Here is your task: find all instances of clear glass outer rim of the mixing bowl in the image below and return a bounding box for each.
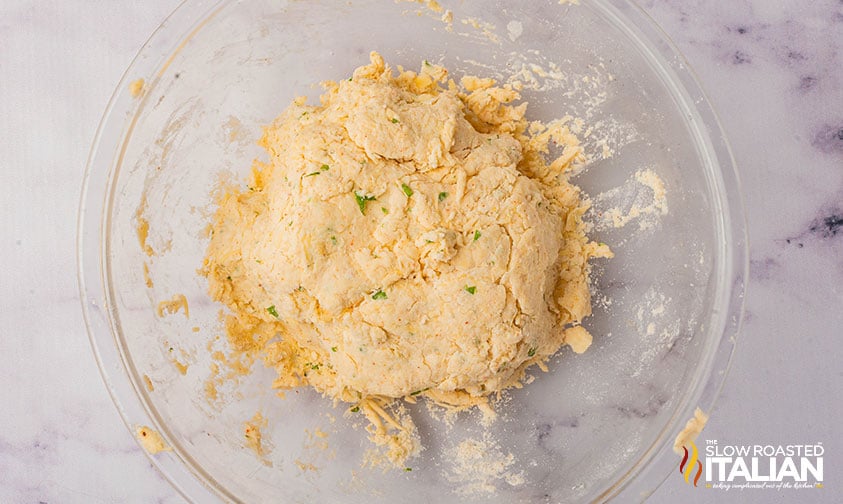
[77,0,749,502]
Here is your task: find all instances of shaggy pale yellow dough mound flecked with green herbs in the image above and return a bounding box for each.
[203,53,611,463]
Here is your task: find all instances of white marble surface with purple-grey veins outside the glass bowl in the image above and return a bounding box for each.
[0,0,843,503]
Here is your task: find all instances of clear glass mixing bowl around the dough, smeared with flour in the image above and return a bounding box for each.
[79,0,747,502]
